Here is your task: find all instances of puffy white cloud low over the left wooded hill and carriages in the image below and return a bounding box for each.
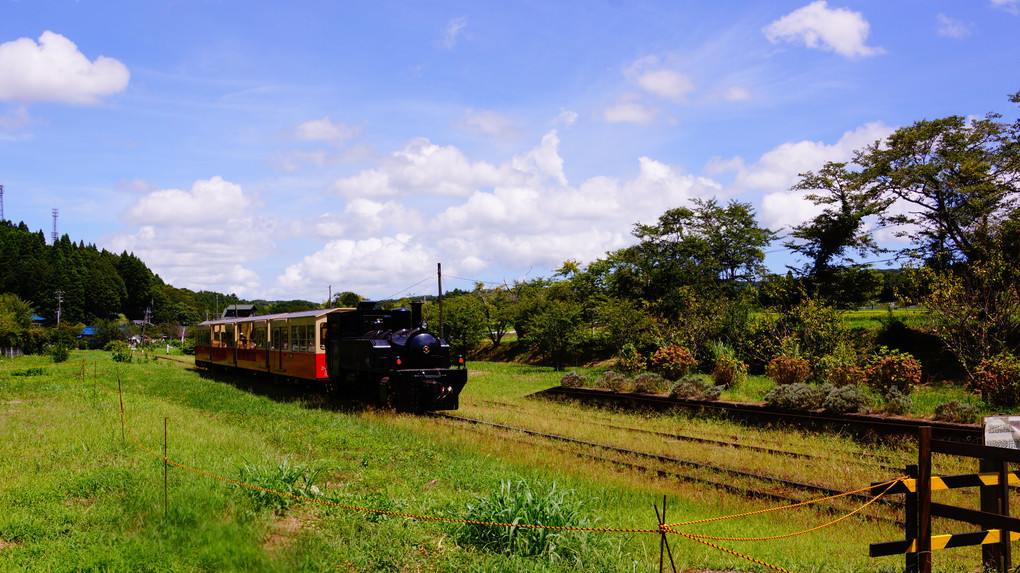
[103,176,273,296]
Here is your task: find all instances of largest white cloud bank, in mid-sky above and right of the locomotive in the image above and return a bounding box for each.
[275,131,723,296]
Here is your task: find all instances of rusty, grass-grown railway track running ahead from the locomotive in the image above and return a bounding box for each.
[429,412,902,521]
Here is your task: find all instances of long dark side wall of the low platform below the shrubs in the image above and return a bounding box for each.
[531,386,983,444]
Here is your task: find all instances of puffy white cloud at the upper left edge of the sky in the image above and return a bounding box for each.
[0,31,131,105]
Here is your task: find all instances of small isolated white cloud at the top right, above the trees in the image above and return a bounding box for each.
[763,0,884,57]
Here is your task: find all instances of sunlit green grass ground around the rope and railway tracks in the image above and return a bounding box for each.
[0,352,991,572]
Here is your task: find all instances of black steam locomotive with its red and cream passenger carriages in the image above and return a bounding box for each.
[195,301,467,413]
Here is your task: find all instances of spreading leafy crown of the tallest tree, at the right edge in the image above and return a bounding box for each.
[855,102,1020,269]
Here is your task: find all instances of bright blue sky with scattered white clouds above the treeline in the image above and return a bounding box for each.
[0,0,1020,301]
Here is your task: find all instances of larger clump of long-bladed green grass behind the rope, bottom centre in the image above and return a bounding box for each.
[458,480,595,562]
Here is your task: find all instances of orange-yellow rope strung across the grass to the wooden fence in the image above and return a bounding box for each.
[71,366,907,573]
